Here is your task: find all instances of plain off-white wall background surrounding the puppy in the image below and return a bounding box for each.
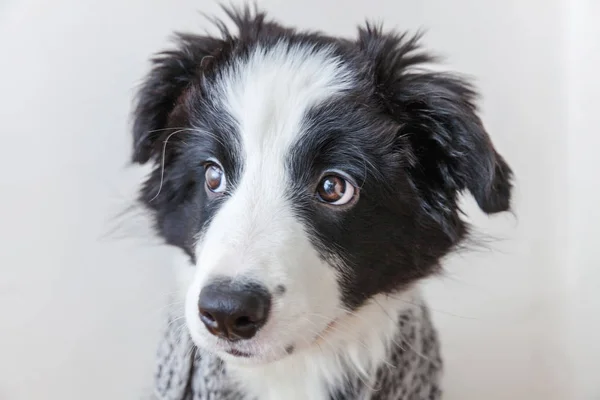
[0,0,600,400]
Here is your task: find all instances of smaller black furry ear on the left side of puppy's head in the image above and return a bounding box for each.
[132,34,225,164]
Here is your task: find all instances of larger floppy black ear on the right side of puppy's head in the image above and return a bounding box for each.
[358,25,512,214]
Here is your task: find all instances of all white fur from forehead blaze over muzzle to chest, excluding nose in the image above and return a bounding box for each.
[173,45,418,400]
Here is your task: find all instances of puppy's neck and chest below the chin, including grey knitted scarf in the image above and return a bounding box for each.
[149,291,441,400]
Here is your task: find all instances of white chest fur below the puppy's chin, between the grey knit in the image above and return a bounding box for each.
[228,290,420,400]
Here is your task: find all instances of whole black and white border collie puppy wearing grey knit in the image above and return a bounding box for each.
[133,9,512,400]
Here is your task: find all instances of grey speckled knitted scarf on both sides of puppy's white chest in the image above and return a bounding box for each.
[150,306,442,400]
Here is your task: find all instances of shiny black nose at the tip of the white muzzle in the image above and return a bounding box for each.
[198,279,271,341]
